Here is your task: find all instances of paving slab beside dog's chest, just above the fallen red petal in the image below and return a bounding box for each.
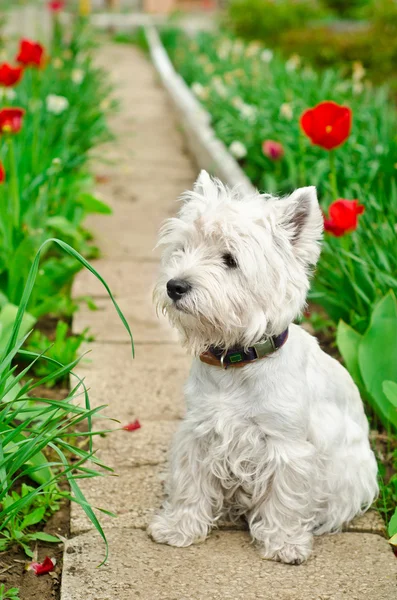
[76,343,191,423]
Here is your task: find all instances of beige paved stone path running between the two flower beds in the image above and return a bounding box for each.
[61,45,397,600]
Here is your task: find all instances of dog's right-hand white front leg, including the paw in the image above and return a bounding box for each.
[248,439,315,564]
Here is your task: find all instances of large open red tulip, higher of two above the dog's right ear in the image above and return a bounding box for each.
[300,102,352,150]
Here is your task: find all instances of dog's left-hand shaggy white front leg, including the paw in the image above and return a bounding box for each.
[148,422,223,546]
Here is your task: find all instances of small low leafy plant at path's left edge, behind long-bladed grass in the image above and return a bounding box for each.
[25,321,90,387]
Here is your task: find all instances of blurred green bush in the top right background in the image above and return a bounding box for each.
[226,0,397,89]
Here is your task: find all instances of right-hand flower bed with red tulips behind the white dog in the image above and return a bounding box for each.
[158,29,397,535]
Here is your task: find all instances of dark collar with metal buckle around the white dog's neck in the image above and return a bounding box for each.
[200,328,288,369]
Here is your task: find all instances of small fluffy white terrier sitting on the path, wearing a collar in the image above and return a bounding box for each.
[149,171,378,563]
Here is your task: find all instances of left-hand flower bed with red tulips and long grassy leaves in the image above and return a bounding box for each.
[0,7,131,598]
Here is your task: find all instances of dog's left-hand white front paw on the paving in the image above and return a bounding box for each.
[147,513,207,548]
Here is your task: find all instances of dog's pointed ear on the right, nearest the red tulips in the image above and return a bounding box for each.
[284,186,324,264]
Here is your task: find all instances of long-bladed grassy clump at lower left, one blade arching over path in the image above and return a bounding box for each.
[0,239,132,554]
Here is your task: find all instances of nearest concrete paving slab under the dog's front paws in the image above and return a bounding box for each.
[62,528,397,600]
